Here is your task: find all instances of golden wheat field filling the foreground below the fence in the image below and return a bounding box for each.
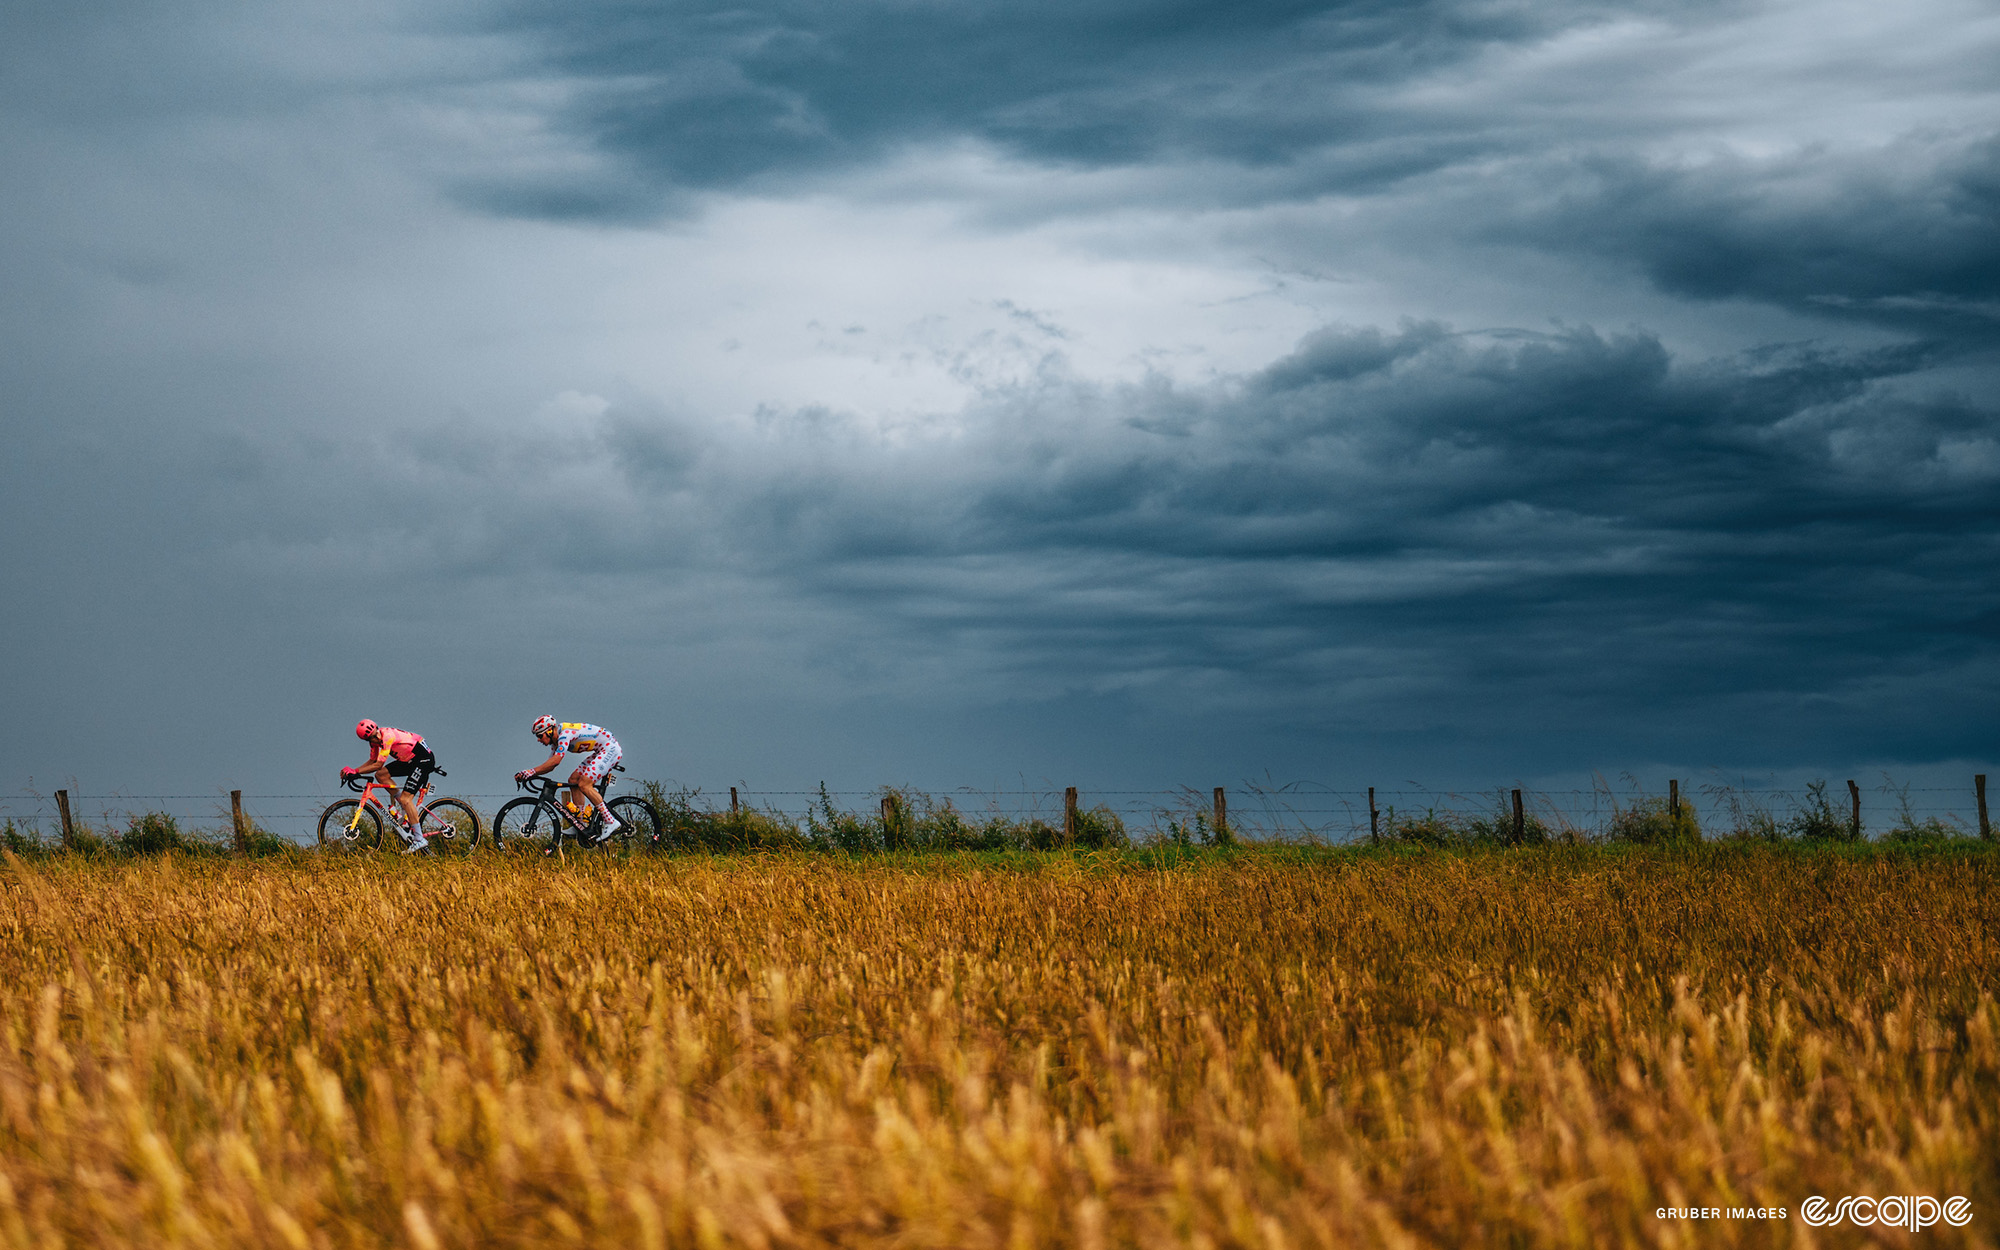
[0,848,2000,1250]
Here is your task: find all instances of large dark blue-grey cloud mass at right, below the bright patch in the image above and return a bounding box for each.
[656,326,2000,750]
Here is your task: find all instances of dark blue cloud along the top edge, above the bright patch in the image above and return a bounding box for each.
[464,0,1656,218]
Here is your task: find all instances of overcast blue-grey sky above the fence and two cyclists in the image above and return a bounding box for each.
[0,0,2000,794]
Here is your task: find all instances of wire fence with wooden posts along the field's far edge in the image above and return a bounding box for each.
[0,774,1988,844]
